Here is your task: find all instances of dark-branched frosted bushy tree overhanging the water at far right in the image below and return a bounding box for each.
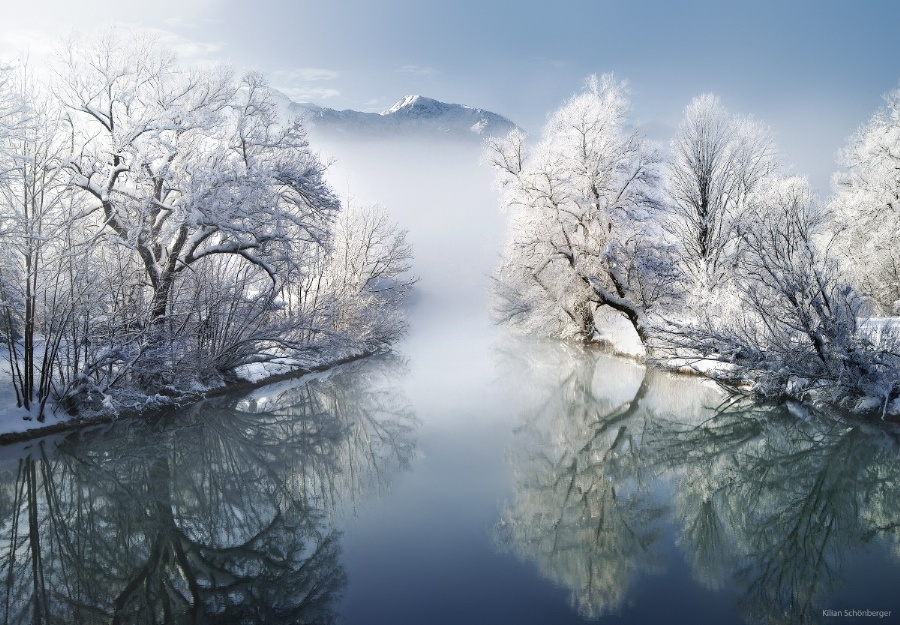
[652,178,900,409]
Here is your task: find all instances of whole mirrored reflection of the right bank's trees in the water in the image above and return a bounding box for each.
[497,346,900,623]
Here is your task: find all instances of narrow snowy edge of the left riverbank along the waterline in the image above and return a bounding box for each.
[0,351,381,445]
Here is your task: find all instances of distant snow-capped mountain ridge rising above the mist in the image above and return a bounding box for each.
[287,95,516,139]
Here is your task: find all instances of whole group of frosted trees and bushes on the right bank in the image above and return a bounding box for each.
[486,76,900,418]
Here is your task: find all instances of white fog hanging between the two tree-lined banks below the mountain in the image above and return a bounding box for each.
[321,138,505,312]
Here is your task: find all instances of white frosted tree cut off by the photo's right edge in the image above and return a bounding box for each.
[831,89,900,314]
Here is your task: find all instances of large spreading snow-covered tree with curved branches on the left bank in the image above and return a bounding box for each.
[50,34,348,394]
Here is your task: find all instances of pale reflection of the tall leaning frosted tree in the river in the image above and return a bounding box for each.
[497,342,662,618]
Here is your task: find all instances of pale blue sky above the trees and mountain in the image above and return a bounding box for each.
[0,0,900,195]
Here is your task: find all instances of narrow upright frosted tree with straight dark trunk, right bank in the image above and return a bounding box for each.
[667,93,775,290]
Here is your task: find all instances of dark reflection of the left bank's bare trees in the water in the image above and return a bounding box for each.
[0,362,416,624]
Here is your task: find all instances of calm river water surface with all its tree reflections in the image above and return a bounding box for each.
[0,342,900,624]
